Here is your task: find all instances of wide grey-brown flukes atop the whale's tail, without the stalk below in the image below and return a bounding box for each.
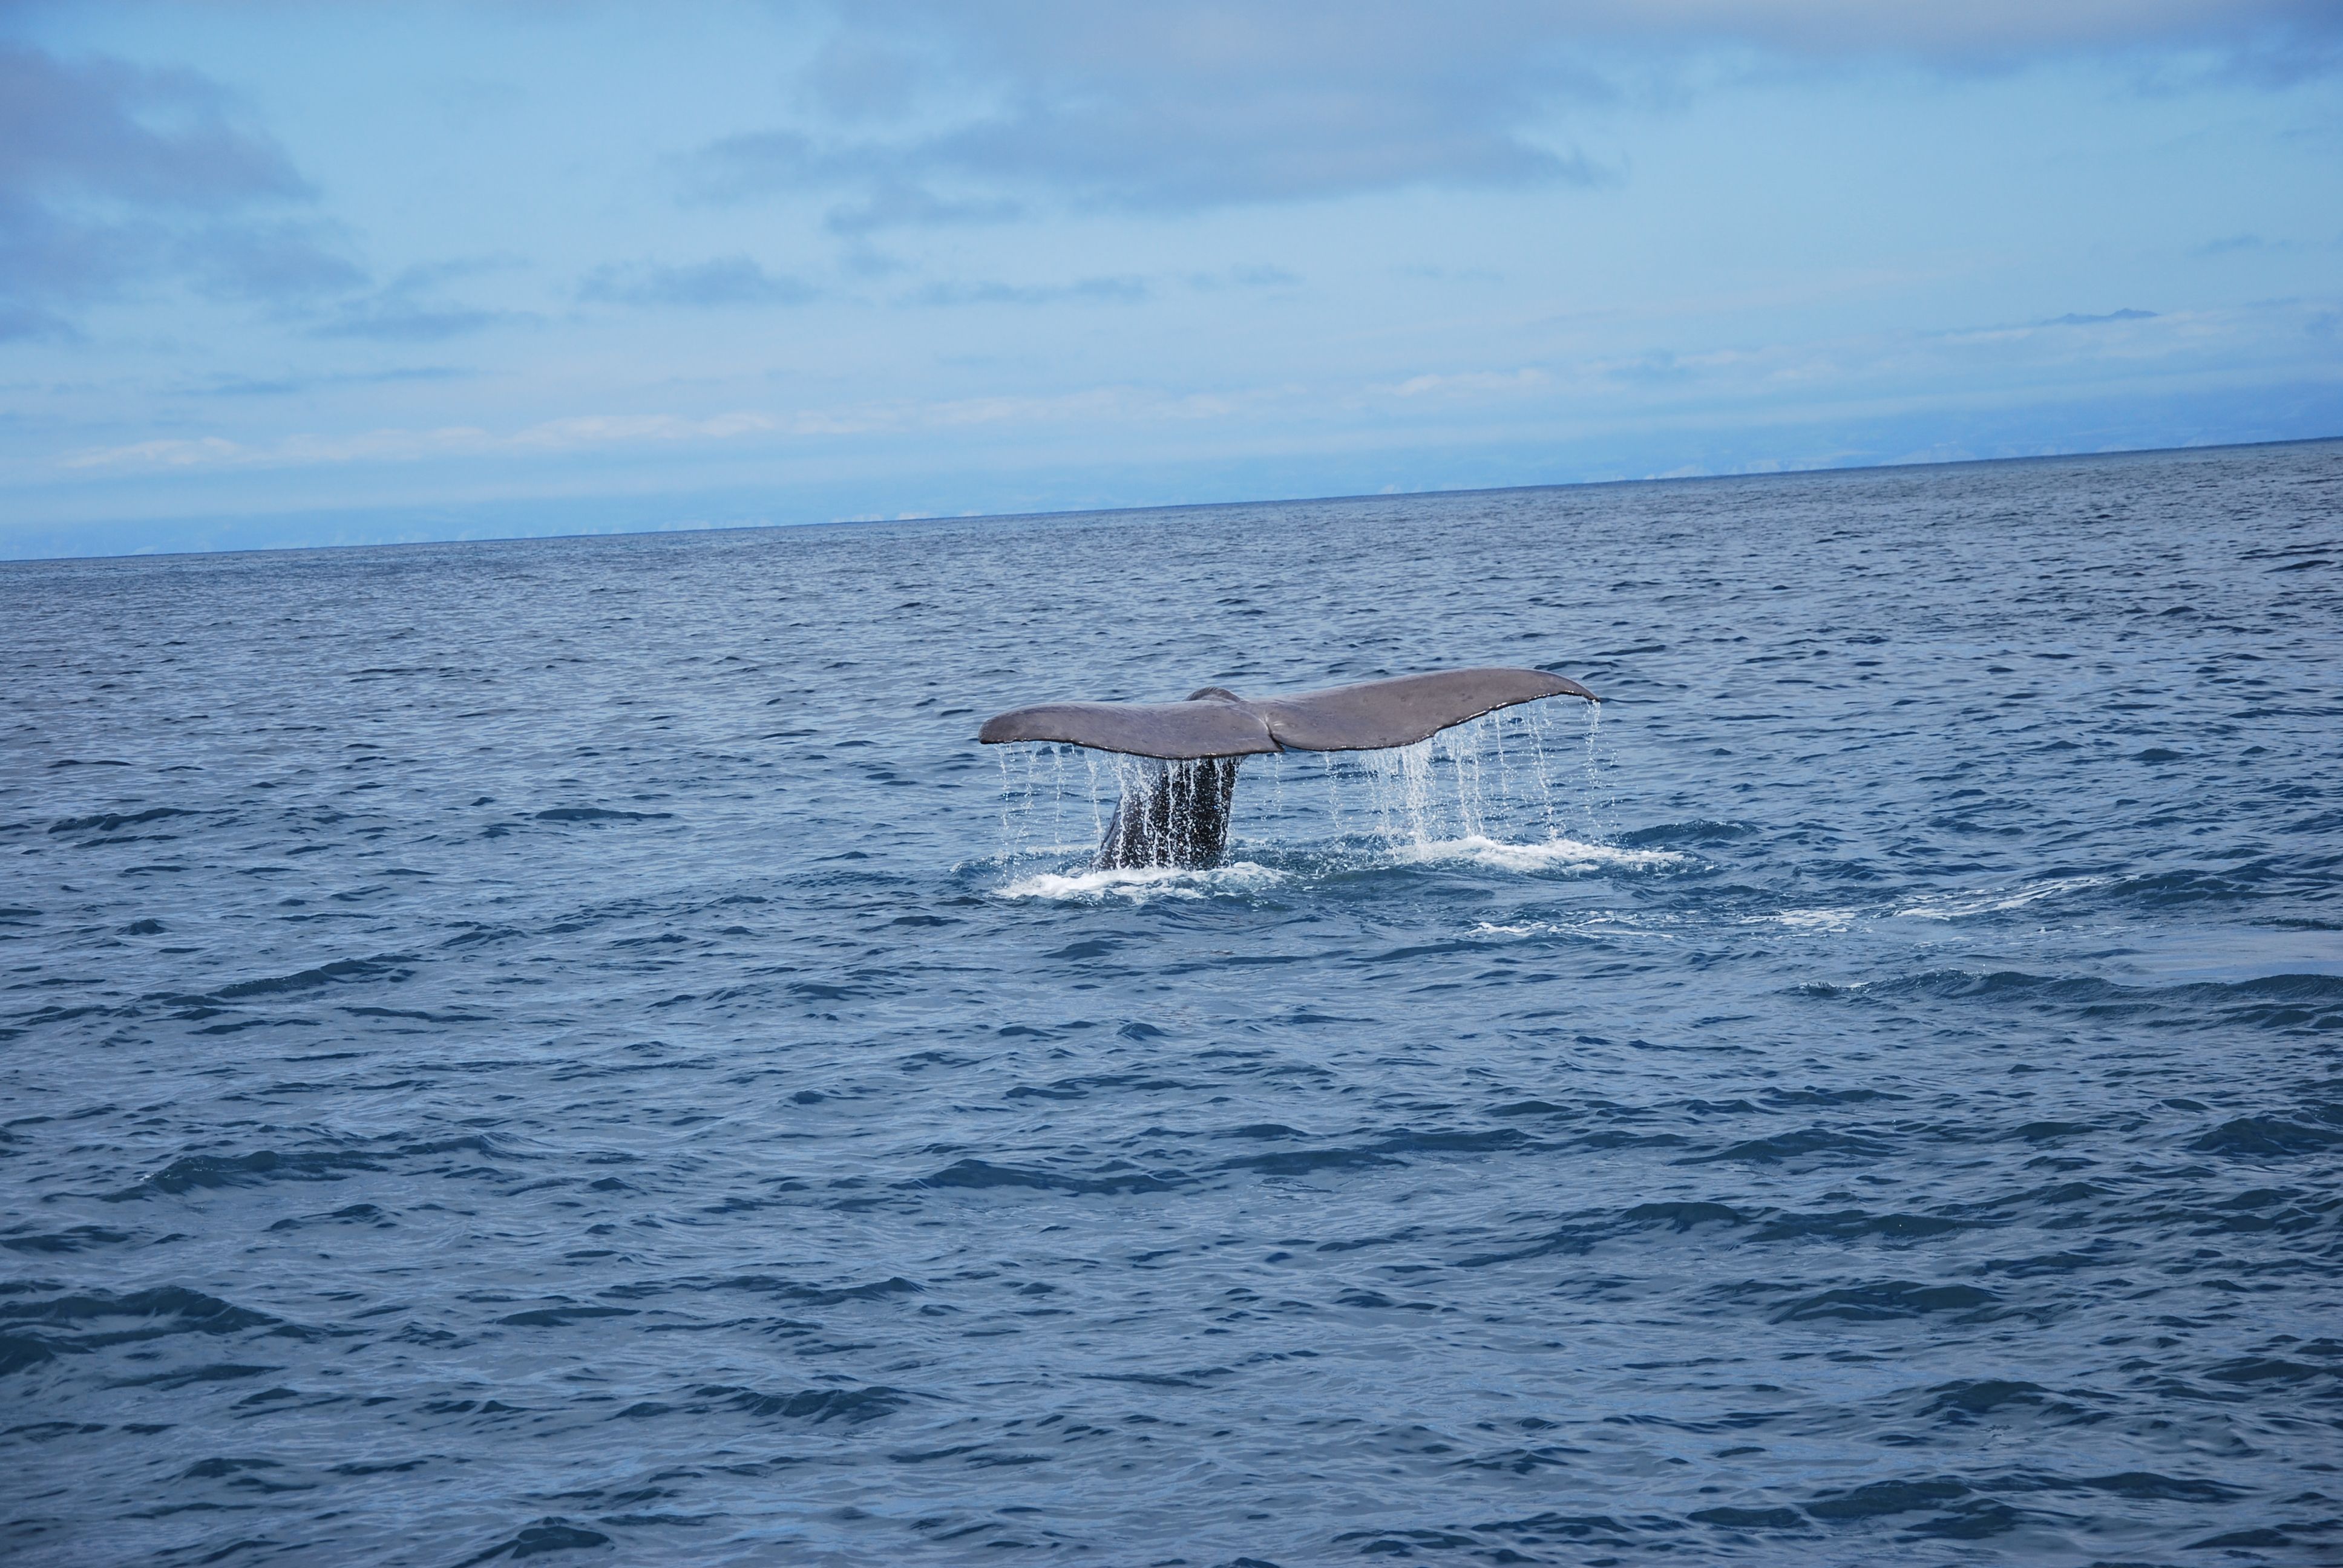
[977,670,1598,762]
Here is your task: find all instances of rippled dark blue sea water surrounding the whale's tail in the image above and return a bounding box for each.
[0,445,2343,1568]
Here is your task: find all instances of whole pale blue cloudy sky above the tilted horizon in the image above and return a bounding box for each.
[0,0,2343,558]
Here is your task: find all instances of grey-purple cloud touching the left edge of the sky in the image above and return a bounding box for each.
[0,45,363,338]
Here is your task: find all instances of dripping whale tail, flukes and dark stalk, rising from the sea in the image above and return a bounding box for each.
[977,668,1602,872]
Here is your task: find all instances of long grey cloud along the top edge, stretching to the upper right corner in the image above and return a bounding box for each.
[684,0,2343,234]
